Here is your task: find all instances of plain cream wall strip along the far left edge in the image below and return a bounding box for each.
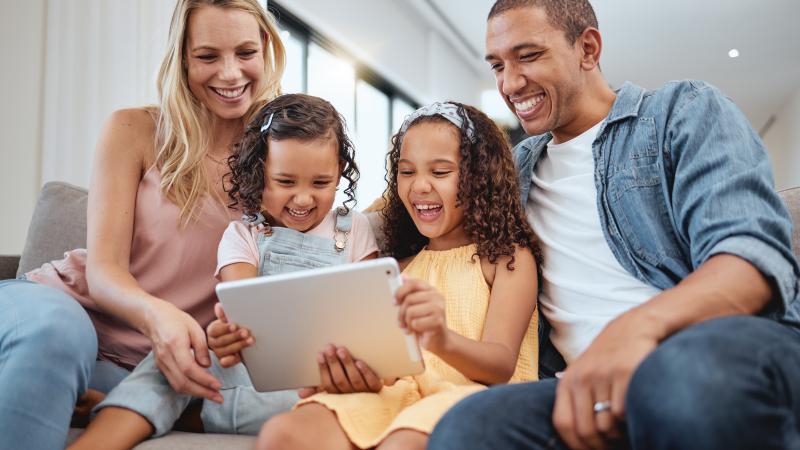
[0,0,46,254]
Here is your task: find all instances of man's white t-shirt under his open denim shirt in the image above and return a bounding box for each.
[525,121,661,363]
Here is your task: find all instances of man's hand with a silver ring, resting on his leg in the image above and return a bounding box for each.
[553,311,659,450]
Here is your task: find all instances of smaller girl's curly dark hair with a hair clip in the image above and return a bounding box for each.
[226,94,360,218]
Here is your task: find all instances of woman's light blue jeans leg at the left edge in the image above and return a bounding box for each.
[0,280,97,449]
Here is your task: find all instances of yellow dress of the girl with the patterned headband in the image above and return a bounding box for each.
[297,244,538,448]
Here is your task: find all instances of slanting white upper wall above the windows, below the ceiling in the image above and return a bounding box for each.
[276,0,492,106]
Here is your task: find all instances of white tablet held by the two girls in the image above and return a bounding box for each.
[212,258,424,392]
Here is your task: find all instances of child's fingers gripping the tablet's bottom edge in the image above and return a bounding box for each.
[297,345,383,398]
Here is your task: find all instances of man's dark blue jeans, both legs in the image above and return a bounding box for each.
[428,317,800,450]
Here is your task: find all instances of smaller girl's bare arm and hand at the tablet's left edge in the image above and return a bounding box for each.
[206,263,258,368]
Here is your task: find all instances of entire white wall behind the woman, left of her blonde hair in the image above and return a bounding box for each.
[0,0,174,254]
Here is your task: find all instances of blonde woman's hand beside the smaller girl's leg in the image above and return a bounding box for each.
[145,301,222,403]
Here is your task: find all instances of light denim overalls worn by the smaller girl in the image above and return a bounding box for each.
[95,208,352,437]
